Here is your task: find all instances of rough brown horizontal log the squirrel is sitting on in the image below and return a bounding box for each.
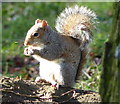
[0,77,101,104]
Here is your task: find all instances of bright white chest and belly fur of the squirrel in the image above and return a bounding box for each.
[33,55,63,83]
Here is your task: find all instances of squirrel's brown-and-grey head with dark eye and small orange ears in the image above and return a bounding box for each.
[24,19,48,46]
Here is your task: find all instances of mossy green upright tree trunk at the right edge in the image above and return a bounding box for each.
[100,2,120,103]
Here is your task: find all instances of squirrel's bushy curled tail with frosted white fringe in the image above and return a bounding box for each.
[56,5,96,47]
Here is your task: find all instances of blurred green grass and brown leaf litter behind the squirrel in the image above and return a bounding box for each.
[1,2,113,91]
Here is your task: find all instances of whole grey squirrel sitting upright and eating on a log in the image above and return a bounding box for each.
[24,5,96,87]
